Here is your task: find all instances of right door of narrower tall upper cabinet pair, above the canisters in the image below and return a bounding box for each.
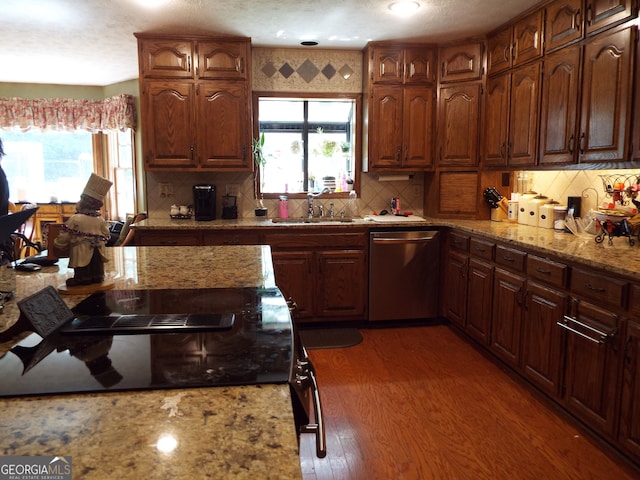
[508,62,541,166]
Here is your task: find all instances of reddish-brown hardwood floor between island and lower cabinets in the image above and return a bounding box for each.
[300,325,640,480]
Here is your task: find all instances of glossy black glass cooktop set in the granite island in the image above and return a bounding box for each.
[0,288,292,397]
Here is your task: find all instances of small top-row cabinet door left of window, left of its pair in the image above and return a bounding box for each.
[138,39,195,78]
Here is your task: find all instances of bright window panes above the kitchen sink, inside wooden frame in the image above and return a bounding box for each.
[254,94,360,198]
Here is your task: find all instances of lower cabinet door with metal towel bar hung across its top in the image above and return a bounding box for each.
[564,301,621,438]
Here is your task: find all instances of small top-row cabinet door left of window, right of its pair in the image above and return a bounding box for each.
[197,41,251,79]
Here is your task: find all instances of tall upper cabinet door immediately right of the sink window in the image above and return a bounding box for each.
[369,86,403,168]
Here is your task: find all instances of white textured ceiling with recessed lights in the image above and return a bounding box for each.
[0,0,540,86]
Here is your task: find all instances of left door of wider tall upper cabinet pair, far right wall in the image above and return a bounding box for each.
[540,46,581,165]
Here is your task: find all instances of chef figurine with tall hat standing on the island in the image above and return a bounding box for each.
[54,173,113,287]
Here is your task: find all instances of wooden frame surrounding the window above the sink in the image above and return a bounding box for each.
[251,91,362,199]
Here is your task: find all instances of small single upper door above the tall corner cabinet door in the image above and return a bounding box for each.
[439,42,484,83]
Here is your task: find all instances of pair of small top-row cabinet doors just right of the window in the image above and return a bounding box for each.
[370,46,436,84]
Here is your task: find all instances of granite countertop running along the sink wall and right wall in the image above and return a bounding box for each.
[135,217,640,278]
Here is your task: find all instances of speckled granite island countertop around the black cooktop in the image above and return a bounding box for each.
[0,246,301,479]
